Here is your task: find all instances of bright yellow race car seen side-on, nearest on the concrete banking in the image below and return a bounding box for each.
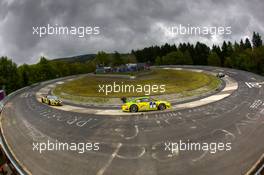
[122,97,171,112]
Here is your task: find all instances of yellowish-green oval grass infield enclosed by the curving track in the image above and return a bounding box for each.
[53,69,220,103]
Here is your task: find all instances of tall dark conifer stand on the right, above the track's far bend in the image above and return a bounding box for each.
[132,32,264,74]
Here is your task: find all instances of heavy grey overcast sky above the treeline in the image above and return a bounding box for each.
[0,0,264,64]
